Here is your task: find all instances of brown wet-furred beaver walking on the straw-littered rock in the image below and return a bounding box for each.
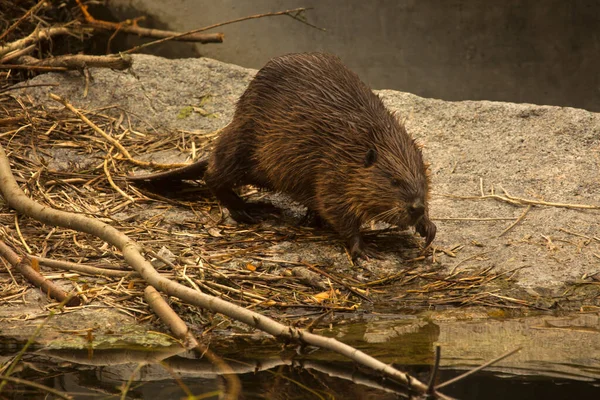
[129,53,436,257]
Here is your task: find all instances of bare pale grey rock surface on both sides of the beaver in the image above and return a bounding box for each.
[15,55,600,291]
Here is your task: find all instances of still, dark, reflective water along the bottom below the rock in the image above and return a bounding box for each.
[0,315,600,400]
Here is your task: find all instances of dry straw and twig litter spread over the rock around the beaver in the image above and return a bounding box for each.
[0,94,531,330]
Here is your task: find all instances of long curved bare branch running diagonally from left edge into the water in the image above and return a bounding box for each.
[0,142,448,399]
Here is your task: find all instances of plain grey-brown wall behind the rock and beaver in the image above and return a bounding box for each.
[110,0,600,111]
